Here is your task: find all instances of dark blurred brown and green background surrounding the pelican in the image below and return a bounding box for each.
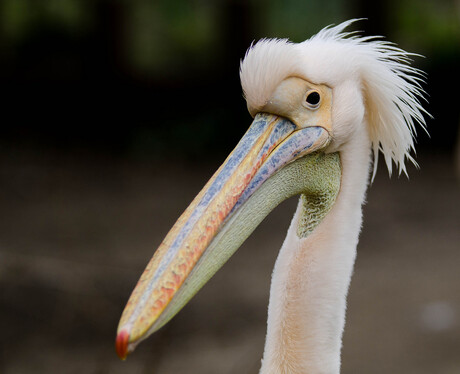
[0,0,460,374]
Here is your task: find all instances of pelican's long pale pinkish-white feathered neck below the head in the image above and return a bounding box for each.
[260,127,371,374]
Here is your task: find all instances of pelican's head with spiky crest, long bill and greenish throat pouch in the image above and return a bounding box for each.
[116,20,424,359]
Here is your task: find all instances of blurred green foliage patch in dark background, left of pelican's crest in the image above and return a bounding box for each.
[125,0,217,74]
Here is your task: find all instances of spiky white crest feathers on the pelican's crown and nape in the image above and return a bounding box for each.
[240,20,427,175]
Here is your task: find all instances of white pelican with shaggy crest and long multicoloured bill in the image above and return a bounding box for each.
[116,20,427,374]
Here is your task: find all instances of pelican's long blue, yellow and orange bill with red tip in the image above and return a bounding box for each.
[116,113,338,359]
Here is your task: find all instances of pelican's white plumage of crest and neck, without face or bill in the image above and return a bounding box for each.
[240,20,426,374]
